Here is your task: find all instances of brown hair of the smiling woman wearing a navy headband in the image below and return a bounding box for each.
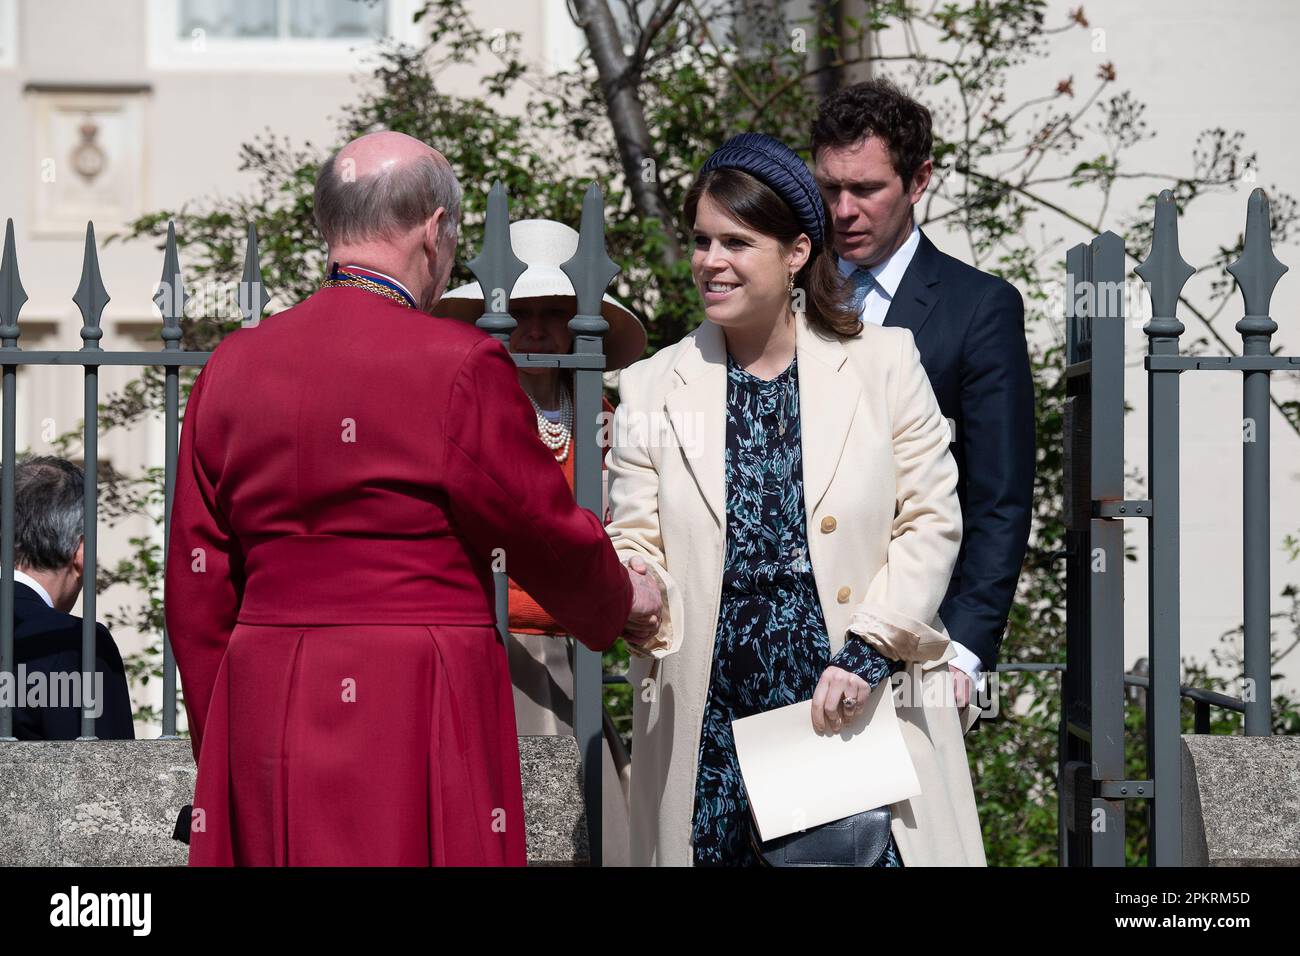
[683,166,862,338]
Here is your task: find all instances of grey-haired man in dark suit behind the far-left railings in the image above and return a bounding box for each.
[5,458,135,740]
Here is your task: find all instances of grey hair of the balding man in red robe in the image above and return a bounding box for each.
[316,153,460,246]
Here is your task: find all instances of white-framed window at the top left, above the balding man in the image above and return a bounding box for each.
[150,0,421,70]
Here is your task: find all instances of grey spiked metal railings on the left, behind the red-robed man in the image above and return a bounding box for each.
[0,183,619,865]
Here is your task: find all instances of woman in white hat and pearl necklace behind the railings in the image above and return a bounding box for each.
[434,219,646,736]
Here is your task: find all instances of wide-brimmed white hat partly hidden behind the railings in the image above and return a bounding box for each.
[433,219,646,372]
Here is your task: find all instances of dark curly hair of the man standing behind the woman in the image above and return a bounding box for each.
[813,79,935,185]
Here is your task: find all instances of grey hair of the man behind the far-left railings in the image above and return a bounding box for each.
[5,457,86,571]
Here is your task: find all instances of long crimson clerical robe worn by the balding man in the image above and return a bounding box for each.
[165,287,632,865]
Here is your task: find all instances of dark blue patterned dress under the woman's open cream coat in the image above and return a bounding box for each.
[692,355,902,866]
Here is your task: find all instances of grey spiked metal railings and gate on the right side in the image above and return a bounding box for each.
[1060,189,1300,866]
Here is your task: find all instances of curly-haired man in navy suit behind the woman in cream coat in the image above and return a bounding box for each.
[813,81,1035,706]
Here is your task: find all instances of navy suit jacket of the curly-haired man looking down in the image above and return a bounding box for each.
[884,233,1035,671]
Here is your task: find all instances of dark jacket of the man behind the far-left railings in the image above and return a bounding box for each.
[13,581,135,740]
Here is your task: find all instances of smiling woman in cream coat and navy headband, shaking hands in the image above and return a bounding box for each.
[607,133,984,866]
